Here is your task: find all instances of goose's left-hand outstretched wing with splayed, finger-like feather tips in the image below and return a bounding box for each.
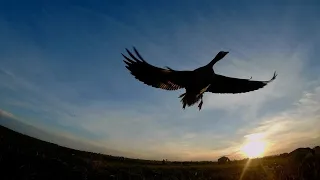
[122,47,192,90]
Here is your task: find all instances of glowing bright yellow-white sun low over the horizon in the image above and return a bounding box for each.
[241,141,266,158]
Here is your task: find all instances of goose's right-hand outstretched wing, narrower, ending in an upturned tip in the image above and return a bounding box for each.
[207,72,277,94]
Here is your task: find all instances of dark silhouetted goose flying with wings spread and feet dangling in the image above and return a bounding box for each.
[121,47,277,111]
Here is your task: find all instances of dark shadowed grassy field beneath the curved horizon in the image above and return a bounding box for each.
[0,126,320,180]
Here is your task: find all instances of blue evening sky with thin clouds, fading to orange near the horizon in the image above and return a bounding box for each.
[0,0,320,160]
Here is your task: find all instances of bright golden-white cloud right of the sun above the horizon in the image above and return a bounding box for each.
[241,86,320,154]
